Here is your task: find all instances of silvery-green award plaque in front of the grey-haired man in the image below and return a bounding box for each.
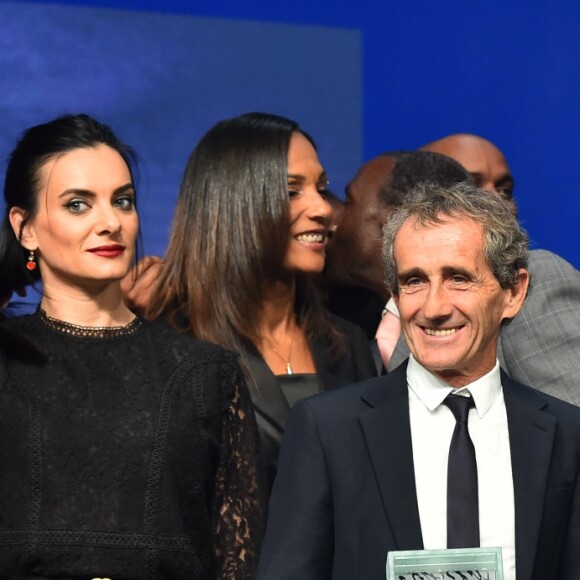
[387,548,503,580]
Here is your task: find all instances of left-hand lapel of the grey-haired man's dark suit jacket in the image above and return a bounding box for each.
[359,364,423,550]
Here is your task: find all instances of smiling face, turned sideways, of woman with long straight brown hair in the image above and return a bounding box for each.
[284,133,332,273]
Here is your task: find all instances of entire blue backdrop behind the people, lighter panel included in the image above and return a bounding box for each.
[0,0,580,267]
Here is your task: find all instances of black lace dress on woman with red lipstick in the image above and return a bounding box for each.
[0,312,263,580]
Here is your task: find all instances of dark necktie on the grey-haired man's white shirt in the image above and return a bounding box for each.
[443,395,479,548]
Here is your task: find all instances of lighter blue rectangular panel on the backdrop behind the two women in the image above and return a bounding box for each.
[0,2,362,255]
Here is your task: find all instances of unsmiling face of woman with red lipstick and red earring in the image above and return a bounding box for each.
[13,144,139,288]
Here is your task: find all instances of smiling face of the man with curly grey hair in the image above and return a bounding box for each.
[394,217,520,387]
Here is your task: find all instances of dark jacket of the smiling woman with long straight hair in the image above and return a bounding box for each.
[243,315,377,494]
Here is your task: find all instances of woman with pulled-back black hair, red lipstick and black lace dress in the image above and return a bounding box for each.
[0,115,262,580]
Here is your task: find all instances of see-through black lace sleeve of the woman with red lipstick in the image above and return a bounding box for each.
[214,365,265,580]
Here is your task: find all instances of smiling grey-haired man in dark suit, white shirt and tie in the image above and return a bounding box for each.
[258,183,580,580]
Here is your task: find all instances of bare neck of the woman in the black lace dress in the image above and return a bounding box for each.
[40,281,135,327]
